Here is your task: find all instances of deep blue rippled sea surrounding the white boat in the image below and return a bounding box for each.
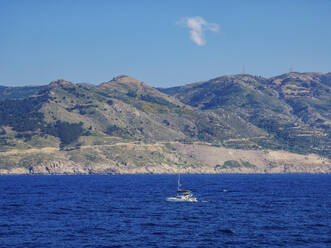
[0,175,331,247]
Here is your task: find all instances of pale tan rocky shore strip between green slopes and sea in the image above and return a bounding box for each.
[0,143,331,175]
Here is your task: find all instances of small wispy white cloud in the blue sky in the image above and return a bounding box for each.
[177,16,219,46]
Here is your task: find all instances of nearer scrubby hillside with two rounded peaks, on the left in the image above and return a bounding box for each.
[0,76,259,153]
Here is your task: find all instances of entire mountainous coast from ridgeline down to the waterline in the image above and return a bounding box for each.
[0,73,331,173]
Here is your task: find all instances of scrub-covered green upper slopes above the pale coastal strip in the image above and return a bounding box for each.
[0,73,331,166]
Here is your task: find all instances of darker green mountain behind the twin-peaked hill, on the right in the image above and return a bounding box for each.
[160,73,331,156]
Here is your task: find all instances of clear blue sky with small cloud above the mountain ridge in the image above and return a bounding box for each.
[0,0,331,87]
